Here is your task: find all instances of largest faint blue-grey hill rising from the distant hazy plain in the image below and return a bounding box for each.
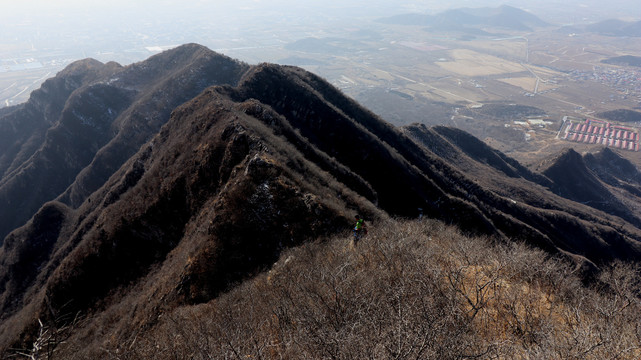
[378,5,549,32]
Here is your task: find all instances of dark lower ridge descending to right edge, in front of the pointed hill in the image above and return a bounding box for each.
[407,126,639,262]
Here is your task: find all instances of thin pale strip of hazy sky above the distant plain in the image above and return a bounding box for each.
[0,0,641,20]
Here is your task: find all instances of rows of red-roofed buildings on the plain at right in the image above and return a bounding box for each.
[562,117,639,151]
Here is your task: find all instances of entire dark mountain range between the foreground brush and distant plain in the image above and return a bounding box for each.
[0,44,641,358]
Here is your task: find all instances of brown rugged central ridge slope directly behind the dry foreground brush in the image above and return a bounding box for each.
[0,78,384,354]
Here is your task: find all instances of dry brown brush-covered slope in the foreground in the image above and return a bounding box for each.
[84,220,641,359]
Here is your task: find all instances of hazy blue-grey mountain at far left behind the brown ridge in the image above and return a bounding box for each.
[0,45,247,242]
